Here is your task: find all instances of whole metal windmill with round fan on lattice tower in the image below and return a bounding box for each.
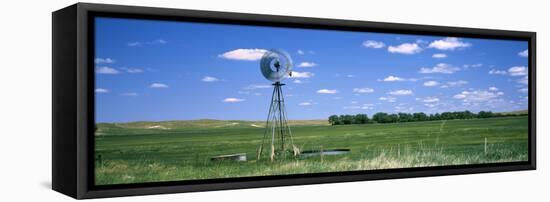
[257,49,300,161]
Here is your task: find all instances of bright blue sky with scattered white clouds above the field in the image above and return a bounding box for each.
[95,18,528,122]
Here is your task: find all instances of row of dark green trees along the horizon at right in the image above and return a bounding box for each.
[328,110,527,125]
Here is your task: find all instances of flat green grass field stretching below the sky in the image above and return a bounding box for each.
[95,116,528,185]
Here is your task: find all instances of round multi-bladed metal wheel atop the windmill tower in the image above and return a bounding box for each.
[260,49,292,82]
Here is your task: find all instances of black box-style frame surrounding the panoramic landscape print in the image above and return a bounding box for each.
[52,3,536,199]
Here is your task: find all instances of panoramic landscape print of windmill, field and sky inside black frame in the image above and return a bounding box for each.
[94,17,529,185]
